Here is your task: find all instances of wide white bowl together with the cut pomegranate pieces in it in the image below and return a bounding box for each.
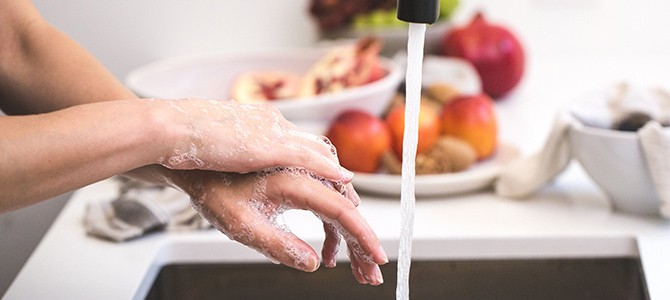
[126,36,403,126]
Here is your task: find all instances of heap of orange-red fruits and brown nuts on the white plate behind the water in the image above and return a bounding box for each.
[326,83,497,175]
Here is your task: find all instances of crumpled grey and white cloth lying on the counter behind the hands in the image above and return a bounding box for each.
[84,177,211,242]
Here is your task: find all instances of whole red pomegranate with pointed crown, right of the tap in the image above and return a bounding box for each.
[441,12,524,99]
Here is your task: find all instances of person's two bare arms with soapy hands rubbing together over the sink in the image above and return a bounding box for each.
[0,0,387,284]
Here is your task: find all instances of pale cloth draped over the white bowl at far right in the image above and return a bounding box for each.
[495,83,670,217]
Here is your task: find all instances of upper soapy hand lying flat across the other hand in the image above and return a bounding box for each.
[160,99,353,182]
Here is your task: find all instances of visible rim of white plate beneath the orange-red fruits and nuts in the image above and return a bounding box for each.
[353,144,519,197]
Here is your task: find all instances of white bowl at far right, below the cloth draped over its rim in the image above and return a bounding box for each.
[569,126,660,215]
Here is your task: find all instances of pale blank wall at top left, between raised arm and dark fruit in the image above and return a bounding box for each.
[34,0,316,78]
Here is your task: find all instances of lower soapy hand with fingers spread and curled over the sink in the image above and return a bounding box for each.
[173,168,388,285]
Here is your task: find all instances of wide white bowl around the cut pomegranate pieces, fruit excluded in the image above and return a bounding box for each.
[126,48,403,124]
